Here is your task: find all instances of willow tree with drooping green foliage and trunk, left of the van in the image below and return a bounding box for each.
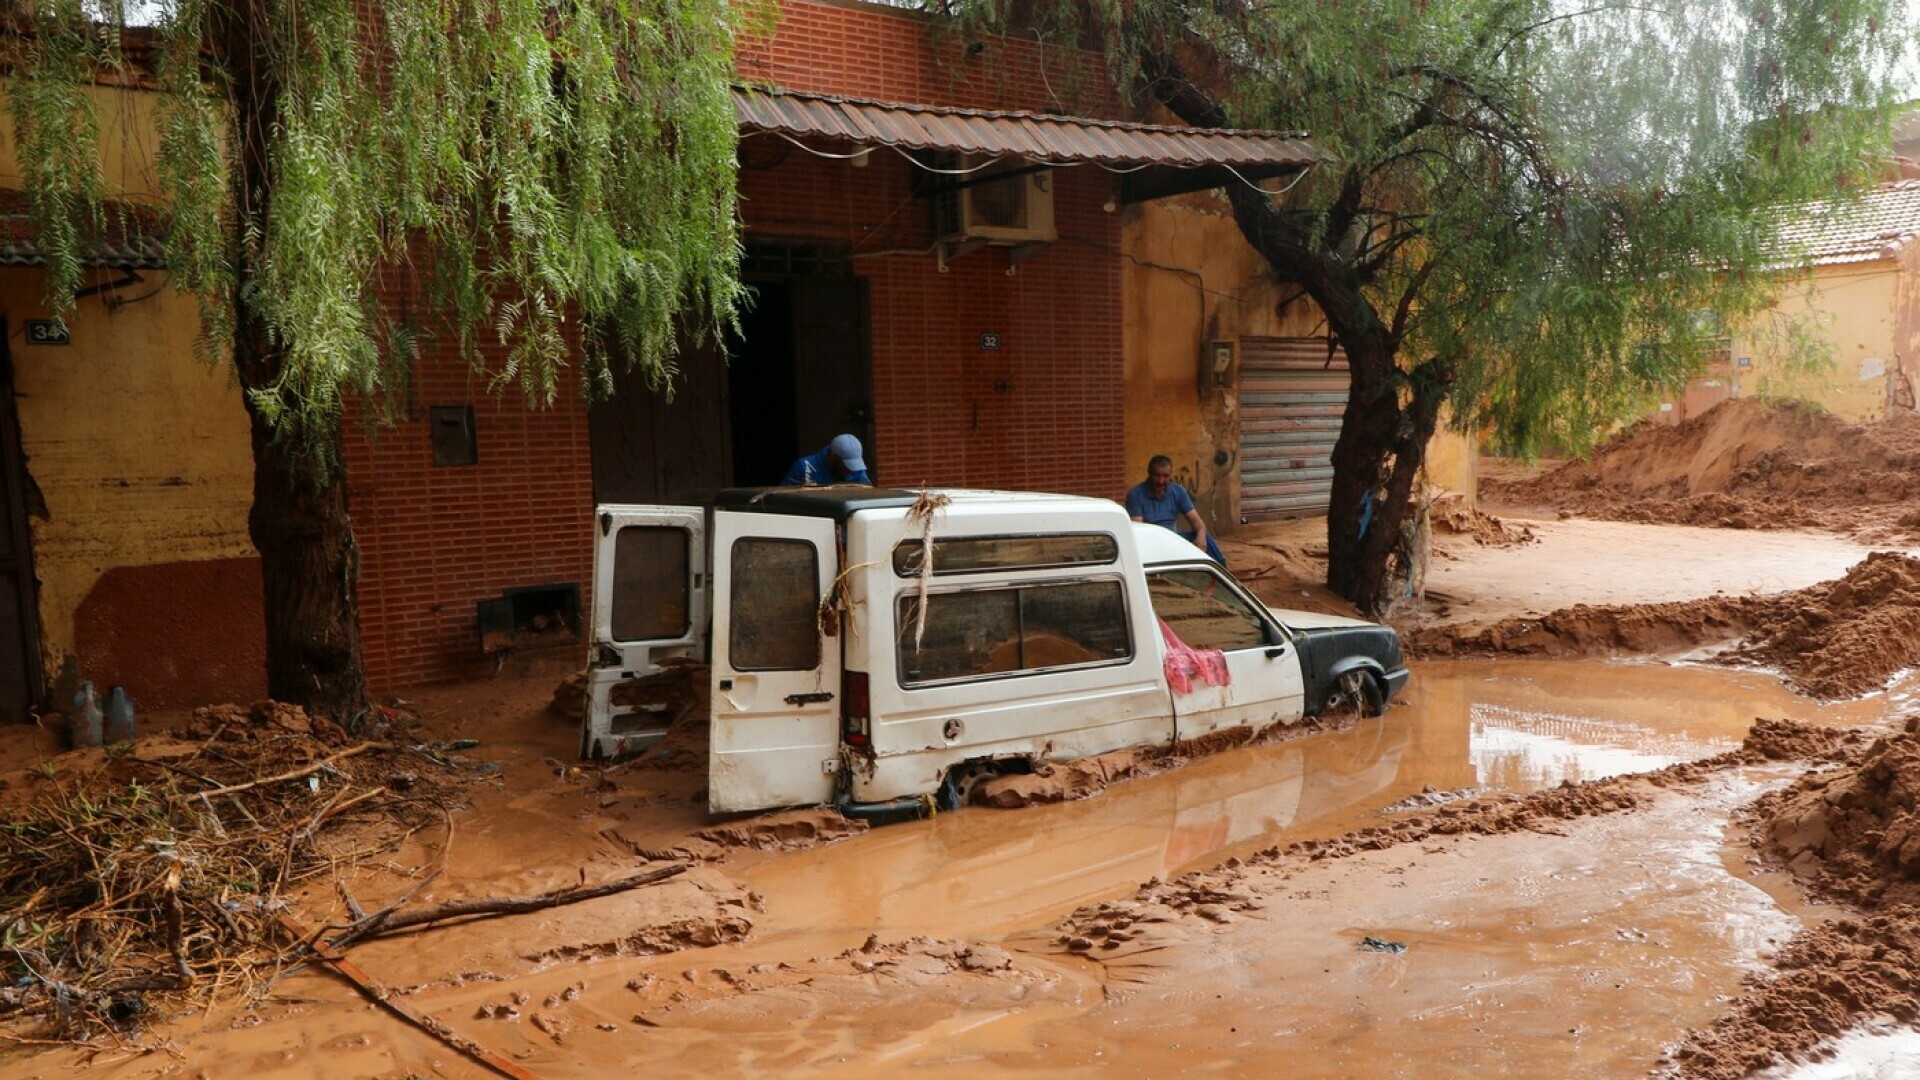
[0,0,743,715]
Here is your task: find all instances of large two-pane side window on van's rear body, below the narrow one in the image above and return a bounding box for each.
[899,580,1133,686]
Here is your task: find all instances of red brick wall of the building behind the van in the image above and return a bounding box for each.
[348,0,1131,690]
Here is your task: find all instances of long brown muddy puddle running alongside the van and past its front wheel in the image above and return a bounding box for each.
[725,661,1889,944]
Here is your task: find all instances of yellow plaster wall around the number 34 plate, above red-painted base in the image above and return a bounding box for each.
[0,269,253,675]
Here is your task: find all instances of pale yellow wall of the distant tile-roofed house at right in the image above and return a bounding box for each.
[1732,259,1912,421]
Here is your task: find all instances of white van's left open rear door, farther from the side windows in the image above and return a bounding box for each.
[580,505,708,757]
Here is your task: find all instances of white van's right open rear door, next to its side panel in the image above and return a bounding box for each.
[707,511,841,813]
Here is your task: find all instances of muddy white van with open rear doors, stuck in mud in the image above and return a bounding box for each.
[582,486,1407,815]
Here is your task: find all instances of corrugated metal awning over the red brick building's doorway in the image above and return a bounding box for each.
[733,86,1319,202]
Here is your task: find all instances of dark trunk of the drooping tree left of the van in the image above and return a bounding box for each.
[213,0,367,721]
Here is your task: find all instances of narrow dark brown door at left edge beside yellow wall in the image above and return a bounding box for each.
[0,319,44,721]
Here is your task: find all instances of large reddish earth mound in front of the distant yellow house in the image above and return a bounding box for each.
[1480,398,1920,538]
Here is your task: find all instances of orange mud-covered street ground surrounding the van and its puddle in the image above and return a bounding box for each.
[11,402,1920,1078]
